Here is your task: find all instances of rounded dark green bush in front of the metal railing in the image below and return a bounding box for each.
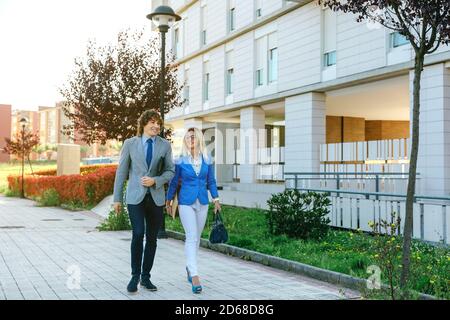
[266,190,330,239]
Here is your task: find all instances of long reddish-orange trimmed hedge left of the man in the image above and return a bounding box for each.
[8,165,117,205]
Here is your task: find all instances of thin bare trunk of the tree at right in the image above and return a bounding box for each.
[400,50,425,289]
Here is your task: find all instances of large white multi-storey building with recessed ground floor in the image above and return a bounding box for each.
[152,0,450,242]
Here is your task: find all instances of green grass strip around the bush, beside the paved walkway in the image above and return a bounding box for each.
[166,205,450,299]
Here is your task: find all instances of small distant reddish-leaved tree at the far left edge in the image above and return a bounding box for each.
[3,131,39,173]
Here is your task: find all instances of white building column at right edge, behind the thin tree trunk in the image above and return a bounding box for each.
[410,63,450,196]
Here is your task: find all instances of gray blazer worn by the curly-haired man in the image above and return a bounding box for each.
[114,136,175,206]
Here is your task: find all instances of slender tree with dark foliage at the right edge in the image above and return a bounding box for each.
[319,0,450,288]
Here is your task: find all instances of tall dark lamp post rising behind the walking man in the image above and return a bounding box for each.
[147,6,181,239]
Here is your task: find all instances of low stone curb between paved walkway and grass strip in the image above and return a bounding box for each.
[166,230,437,300]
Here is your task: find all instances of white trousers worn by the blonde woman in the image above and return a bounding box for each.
[178,199,208,277]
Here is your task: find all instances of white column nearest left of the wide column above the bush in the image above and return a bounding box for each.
[239,107,266,183]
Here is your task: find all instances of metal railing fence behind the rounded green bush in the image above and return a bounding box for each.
[284,172,450,244]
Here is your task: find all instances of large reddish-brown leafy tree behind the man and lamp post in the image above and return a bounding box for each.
[60,30,183,145]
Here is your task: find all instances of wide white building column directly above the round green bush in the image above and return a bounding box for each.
[284,92,326,172]
